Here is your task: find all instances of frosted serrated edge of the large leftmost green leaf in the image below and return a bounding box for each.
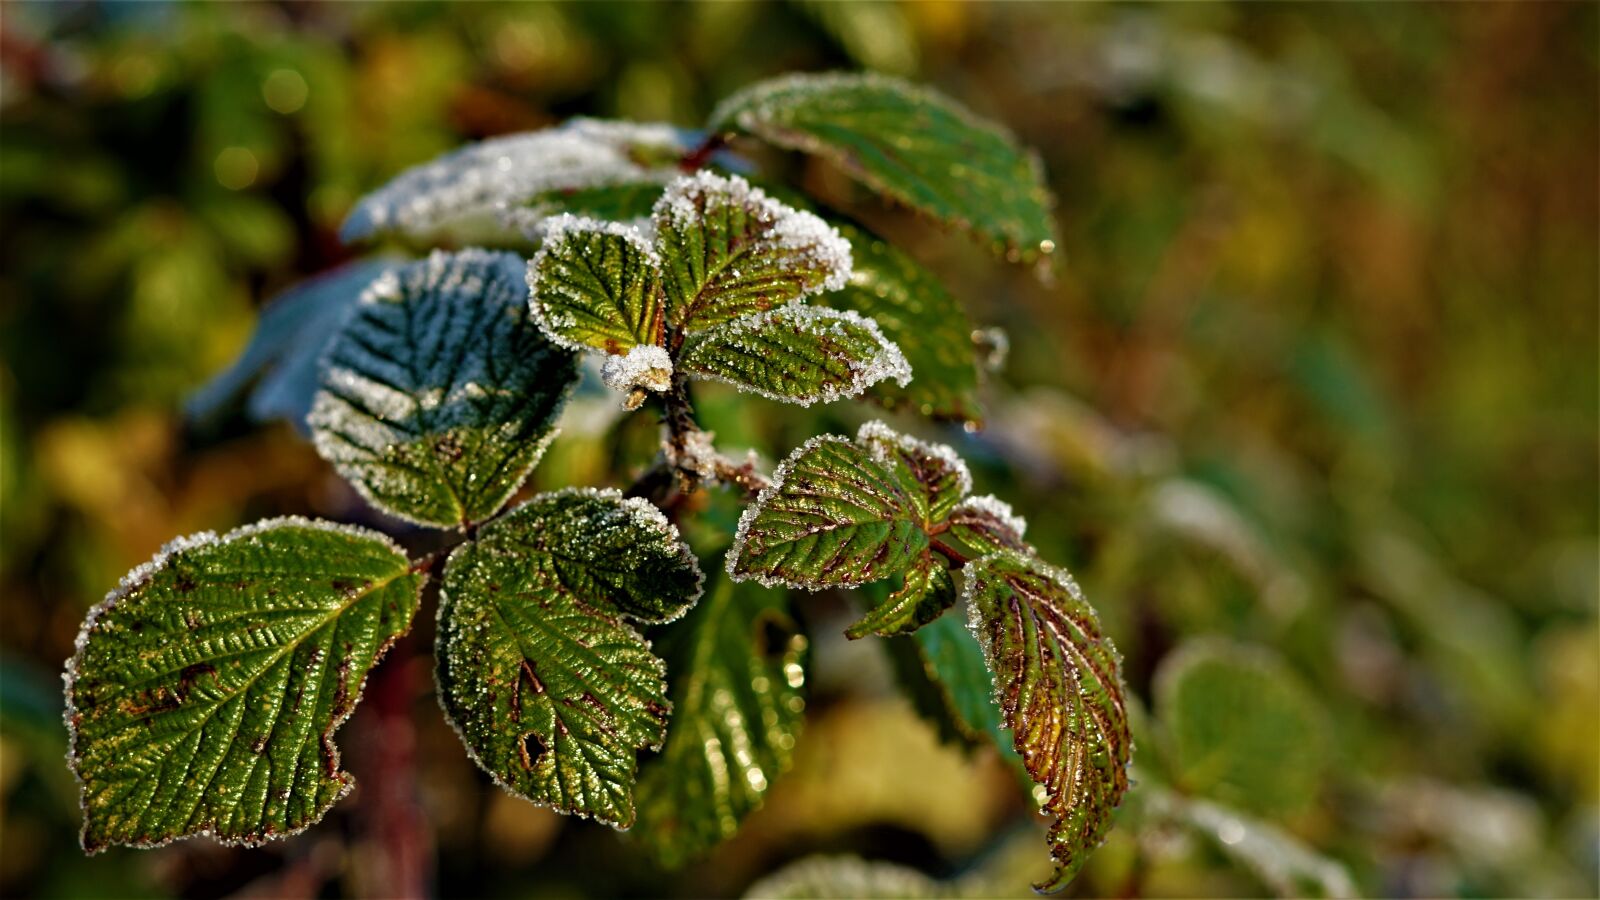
[61,516,414,857]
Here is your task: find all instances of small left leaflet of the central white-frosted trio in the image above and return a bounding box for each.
[528,216,662,354]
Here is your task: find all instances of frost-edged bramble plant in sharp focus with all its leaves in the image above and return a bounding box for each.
[67,74,1131,890]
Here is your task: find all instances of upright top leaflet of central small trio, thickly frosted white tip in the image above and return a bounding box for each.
[654,171,850,330]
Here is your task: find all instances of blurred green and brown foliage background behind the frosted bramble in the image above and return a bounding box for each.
[0,0,1600,897]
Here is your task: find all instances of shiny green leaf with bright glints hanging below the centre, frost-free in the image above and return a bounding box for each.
[638,578,806,868]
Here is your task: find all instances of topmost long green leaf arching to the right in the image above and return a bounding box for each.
[710,74,1056,259]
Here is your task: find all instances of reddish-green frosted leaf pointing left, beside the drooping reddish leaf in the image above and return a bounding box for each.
[728,436,928,591]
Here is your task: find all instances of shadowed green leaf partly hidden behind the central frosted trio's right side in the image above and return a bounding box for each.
[813,223,984,423]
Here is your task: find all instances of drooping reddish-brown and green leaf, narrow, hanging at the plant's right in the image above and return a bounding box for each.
[962,551,1133,890]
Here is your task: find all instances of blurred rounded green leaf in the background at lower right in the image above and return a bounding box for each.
[1155,641,1328,815]
